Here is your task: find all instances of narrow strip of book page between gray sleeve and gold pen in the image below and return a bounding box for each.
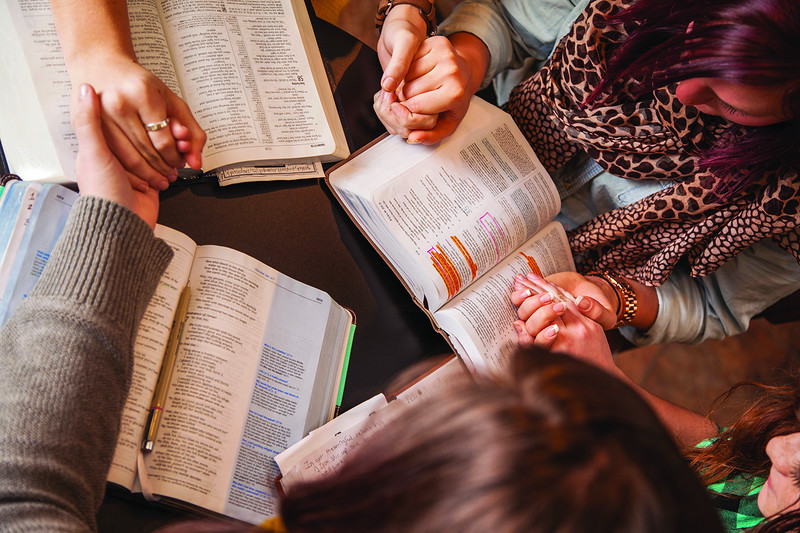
[107,225,197,490]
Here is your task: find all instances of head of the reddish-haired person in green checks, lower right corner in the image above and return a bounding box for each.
[690,378,800,533]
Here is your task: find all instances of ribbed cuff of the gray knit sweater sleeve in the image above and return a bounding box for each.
[31,196,173,331]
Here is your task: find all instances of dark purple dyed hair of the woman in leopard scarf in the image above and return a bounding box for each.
[585,0,800,198]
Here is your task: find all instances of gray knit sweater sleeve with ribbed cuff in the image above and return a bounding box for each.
[0,197,172,531]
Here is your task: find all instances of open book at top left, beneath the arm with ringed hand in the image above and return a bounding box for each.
[0,0,349,185]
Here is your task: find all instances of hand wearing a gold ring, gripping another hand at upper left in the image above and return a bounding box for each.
[70,54,206,191]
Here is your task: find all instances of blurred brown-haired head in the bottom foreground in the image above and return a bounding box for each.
[281,348,721,533]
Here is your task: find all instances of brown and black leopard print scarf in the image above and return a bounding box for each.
[506,0,800,285]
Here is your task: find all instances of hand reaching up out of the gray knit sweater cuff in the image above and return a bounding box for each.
[72,84,158,227]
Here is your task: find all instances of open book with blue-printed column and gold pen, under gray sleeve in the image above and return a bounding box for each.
[0,182,354,523]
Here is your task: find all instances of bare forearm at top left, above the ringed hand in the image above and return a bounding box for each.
[50,0,136,70]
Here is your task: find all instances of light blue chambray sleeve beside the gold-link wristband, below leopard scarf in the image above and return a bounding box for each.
[621,240,800,345]
